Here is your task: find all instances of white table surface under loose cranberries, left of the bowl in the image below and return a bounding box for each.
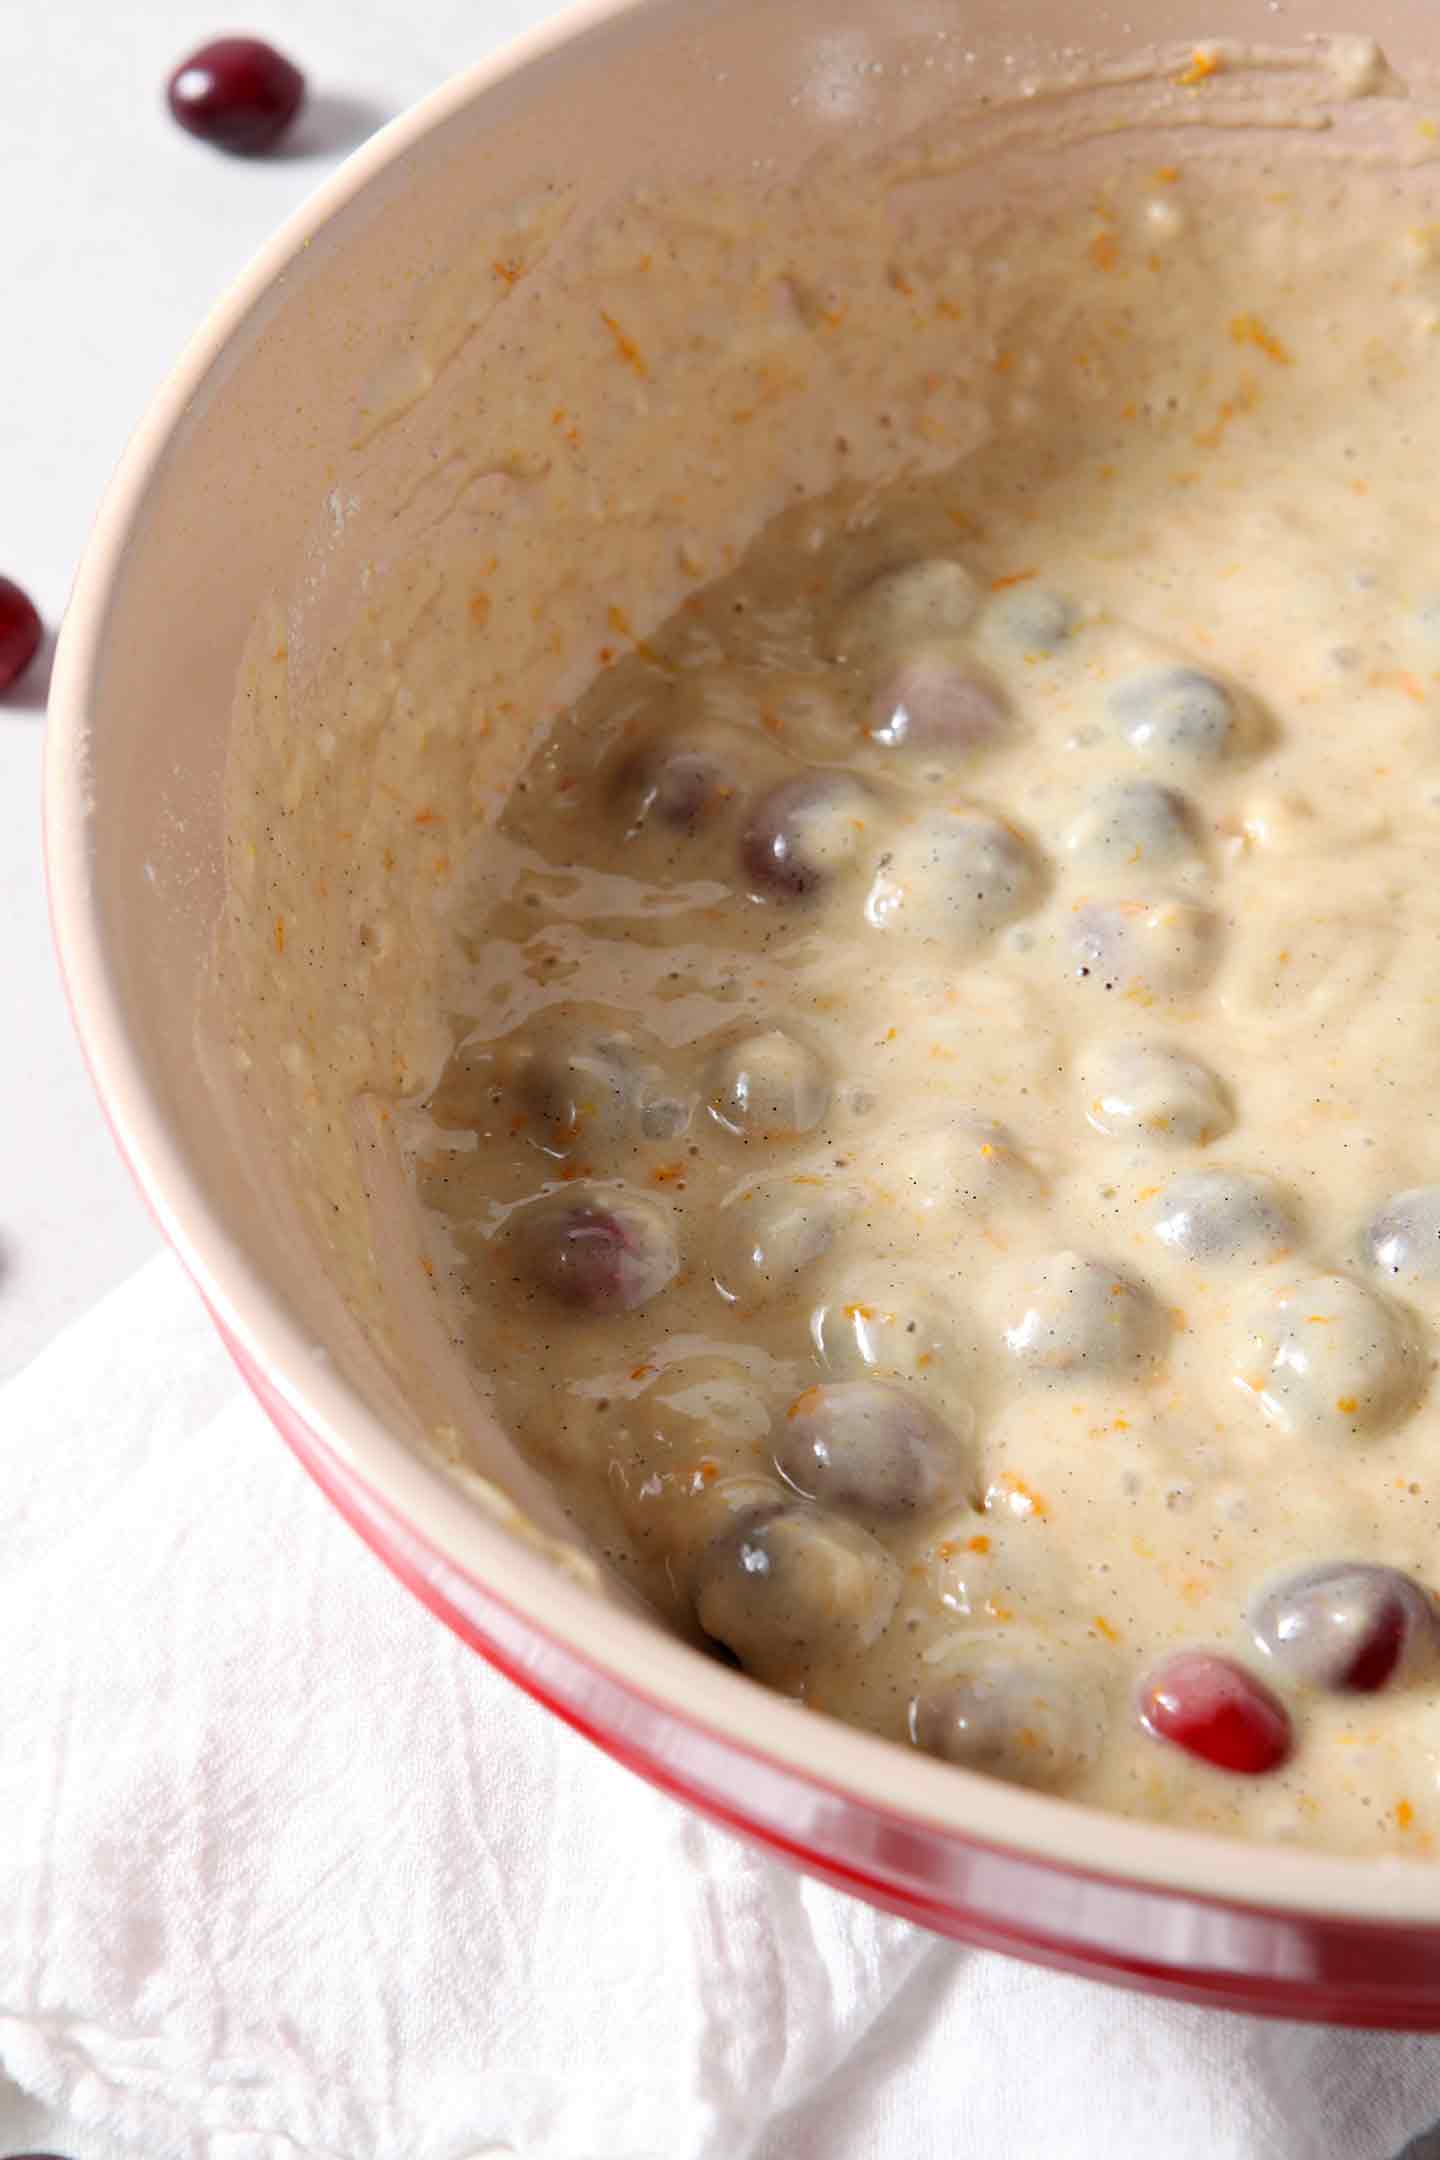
[0,0,1440,2160]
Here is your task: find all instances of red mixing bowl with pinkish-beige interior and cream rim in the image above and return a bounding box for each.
[45,0,1440,2026]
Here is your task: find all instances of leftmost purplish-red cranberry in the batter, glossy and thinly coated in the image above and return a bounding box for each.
[507,1186,680,1313]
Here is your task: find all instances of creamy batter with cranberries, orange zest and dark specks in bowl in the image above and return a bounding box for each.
[222,38,1440,1855]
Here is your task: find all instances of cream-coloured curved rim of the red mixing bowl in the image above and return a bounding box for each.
[43,0,1440,1929]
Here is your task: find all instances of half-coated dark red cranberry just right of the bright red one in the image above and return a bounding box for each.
[1250,1560,1438,1696]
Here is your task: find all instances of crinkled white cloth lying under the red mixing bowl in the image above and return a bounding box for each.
[0,1259,1440,2160]
